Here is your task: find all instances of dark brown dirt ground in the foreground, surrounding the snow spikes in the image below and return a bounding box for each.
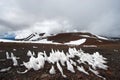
[0,42,120,80]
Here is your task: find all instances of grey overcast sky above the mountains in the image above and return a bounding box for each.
[0,0,120,36]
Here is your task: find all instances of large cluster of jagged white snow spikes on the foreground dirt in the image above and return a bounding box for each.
[20,48,108,77]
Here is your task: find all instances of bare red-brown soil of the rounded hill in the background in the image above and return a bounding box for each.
[47,32,117,45]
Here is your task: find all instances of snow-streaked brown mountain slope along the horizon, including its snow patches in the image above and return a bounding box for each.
[2,32,116,45]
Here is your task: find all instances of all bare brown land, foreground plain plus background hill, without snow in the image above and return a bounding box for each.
[0,33,120,80]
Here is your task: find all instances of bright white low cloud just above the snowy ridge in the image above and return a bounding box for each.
[29,20,73,34]
